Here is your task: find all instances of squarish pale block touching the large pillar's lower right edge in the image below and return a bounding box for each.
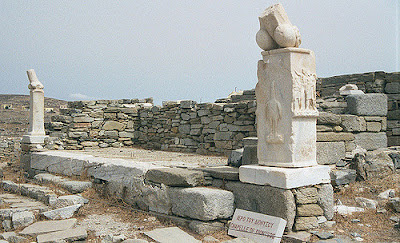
[317,142,346,165]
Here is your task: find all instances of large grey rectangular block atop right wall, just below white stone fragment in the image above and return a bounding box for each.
[346,94,388,116]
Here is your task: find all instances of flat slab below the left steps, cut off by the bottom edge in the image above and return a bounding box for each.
[36,228,87,243]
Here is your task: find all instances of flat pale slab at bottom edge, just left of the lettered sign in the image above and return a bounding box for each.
[143,227,200,243]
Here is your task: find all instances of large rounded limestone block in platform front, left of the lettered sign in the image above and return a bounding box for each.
[168,187,234,221]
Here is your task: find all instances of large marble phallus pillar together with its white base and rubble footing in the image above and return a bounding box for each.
[239,4,333,231]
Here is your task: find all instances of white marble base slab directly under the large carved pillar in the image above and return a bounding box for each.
[239,165,331,189]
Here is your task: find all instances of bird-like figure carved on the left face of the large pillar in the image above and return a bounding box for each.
[266,81,283,143]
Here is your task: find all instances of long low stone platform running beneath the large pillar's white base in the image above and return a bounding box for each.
[26,148,333,233]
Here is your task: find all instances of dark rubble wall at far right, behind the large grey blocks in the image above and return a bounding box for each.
[317,72,400,146]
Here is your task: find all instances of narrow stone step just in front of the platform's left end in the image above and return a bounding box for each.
[33,172,93,194]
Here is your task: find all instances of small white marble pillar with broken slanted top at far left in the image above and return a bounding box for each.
[22,69,46,144]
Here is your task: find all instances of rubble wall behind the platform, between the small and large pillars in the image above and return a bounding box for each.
[46,97,256,153]
